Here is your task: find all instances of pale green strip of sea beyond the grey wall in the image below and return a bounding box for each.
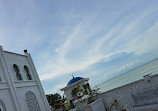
[97,59,158,92]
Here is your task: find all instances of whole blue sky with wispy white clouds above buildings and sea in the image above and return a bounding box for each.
[0,0,158,94]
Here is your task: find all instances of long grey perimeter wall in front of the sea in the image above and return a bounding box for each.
[99,74,158,111]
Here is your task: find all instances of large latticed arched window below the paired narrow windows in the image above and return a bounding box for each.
[25,91,41,111]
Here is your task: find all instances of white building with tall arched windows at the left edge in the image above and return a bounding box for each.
[0,46,50,111]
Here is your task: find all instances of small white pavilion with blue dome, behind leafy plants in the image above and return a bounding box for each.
[61,77,89,104]
